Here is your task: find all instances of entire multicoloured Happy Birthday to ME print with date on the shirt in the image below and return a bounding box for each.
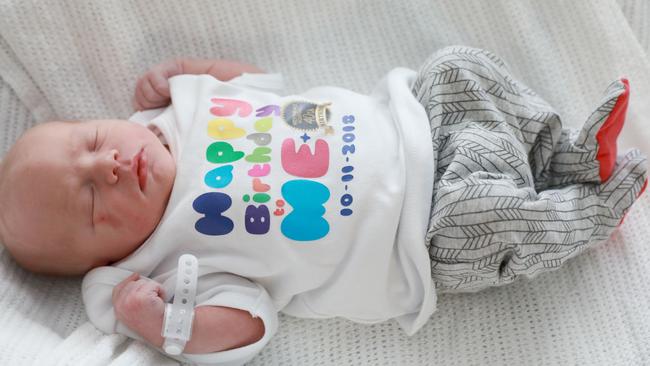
[192,98,340,237]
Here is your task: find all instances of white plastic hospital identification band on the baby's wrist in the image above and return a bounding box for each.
[162,254,199,355]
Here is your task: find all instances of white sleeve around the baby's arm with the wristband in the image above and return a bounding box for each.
[82,267,278,366]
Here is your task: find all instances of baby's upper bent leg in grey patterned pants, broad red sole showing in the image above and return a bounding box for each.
[413,46,629,191]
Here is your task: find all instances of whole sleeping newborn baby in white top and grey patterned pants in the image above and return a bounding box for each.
[0,47,646,364]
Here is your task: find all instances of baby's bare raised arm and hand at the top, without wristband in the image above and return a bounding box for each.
[133,58,263,111]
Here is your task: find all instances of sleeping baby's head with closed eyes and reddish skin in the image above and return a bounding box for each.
[0,120,176,275]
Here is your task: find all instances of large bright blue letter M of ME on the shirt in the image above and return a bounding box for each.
[280,179,330,241]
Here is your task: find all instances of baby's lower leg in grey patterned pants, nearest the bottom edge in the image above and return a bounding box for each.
[427,132,645,292]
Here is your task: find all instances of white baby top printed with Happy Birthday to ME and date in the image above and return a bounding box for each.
[83,68,436,365]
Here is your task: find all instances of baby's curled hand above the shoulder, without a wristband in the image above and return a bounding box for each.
[133,59,183,111]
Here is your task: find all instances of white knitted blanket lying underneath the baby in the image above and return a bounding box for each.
[0,0,650,365]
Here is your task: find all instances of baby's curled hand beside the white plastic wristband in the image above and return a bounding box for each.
[113,273,165,347]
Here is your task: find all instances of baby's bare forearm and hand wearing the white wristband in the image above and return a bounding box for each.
[112,273,264,353]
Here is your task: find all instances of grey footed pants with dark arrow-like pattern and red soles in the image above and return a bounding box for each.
[413,47,646,292]
